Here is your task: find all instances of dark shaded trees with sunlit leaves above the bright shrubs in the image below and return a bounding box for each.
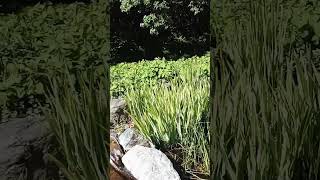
[111,0,210,63]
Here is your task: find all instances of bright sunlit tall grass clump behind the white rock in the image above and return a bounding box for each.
[125,68,209,174]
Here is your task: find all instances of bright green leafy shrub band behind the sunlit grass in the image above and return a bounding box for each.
[111,54,210,96]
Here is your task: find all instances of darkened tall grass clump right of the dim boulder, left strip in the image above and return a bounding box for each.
[42,66,110,180]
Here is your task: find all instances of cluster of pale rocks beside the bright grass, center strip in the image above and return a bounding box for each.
[110,100,180,180]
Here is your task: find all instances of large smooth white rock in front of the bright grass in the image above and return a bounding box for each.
[122,145,180,180]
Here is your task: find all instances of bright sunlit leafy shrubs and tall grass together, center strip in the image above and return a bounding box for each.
[110,54,210,175]
